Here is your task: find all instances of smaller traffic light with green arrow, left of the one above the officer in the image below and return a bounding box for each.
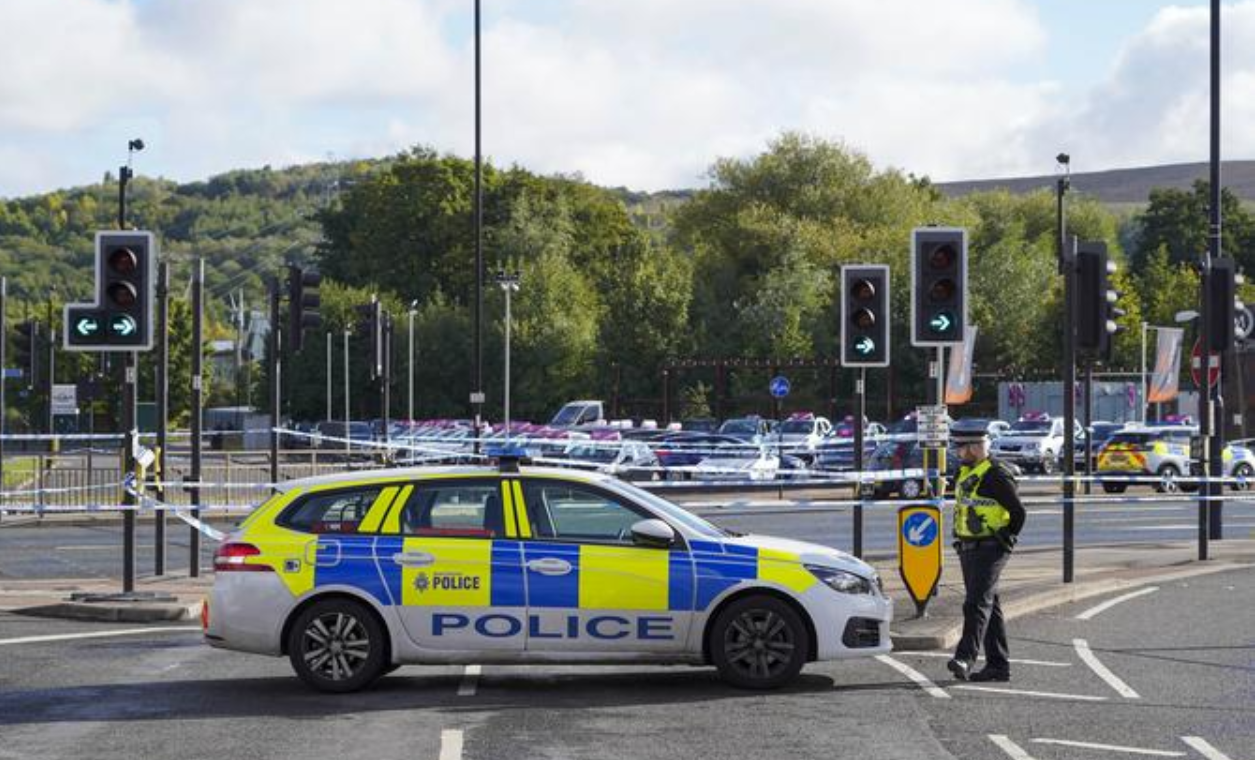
[841,265,890,366]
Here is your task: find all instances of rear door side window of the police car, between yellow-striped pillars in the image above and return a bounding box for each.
[397,480,506,538]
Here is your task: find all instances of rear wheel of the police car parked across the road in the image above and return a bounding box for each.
[287,599,392,694]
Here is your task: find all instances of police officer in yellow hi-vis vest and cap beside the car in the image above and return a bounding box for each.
[946,425,1024,681]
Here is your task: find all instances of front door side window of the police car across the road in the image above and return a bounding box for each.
[525,480,649,546]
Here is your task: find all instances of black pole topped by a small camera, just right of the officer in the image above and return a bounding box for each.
[1055,176,1077,583]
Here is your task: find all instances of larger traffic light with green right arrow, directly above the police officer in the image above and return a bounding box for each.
[911,227,968,346]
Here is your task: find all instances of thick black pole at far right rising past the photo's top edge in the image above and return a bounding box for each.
[1200,0,1232,541]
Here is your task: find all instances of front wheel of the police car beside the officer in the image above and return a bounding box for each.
[710,596,811,689]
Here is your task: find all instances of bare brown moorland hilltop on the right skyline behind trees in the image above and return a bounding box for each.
[936,161,1255,204]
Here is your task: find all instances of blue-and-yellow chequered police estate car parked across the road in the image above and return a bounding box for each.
[202,460,892,692]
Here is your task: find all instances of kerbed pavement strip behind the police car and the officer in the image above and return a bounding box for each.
[0,539,1255,651]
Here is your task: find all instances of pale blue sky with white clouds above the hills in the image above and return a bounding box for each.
[0,0,1255,198]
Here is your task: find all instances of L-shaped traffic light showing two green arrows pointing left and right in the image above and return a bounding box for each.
[64,231,157,351]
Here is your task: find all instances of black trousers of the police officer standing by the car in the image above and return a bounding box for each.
[954,541,1012,672]
